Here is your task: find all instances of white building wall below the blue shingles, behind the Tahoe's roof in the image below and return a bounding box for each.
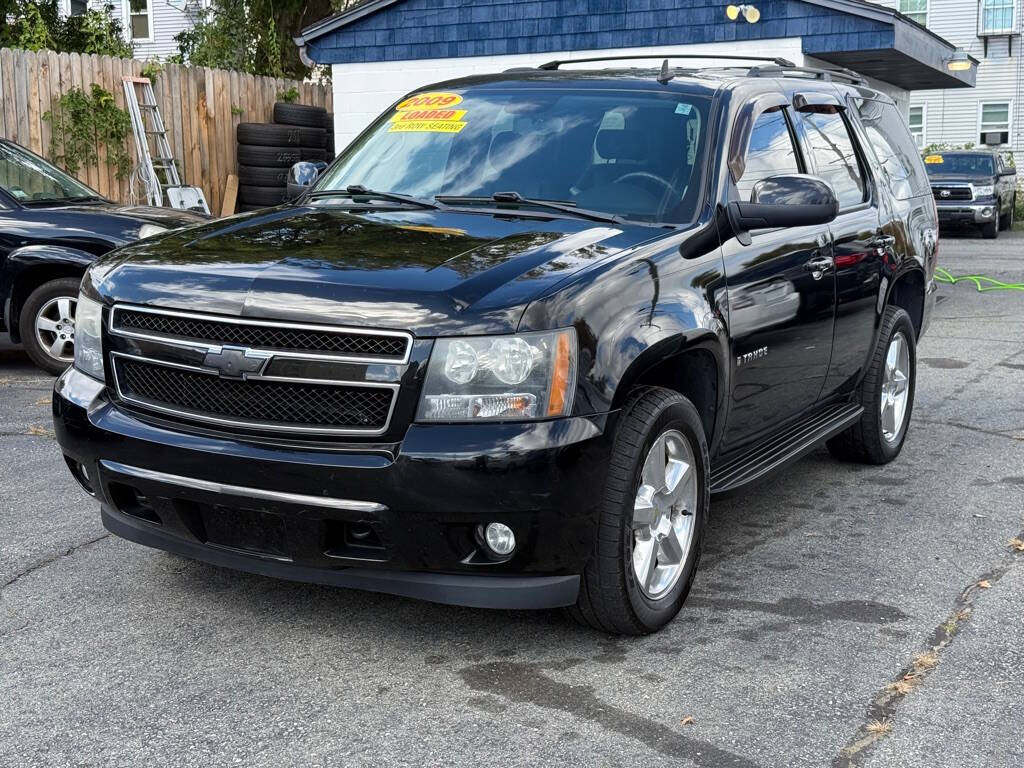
[332,38,907,150]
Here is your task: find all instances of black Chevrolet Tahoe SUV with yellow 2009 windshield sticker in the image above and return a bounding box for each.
[53,61,937,634]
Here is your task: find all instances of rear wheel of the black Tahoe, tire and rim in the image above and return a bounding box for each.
[827,306,918,464]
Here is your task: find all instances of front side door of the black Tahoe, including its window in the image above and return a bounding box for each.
[722,106,836,450]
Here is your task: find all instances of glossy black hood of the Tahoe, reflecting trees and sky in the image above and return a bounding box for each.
[90,205,668,336]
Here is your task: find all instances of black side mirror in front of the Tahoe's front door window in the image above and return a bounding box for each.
[728,173,839,245]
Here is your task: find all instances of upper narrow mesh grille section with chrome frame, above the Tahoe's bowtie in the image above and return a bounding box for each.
[111,306,411,362]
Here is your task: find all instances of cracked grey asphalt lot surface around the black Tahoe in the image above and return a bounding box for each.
[0,232,1024,768]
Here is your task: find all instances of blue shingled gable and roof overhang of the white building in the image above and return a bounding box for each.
[295,0,975,90]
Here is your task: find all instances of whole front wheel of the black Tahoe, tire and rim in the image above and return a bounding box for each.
[569,387,710,635]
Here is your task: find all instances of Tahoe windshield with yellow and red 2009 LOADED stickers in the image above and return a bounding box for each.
[313,88,709,223]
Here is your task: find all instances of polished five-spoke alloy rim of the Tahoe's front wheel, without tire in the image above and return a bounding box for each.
[632,429,697,600]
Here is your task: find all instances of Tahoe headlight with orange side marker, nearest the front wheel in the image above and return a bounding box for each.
[417,329,577,422]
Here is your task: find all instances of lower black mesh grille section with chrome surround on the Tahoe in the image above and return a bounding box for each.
[114,354,395,433]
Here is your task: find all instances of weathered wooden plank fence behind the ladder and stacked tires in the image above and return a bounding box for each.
[0,48,332,214]
